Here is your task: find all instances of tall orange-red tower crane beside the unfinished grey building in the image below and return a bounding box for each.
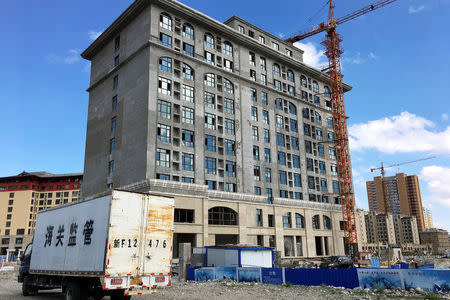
[286,0,397,257]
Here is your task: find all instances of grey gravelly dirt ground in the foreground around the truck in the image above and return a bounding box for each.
[0,271,450,300]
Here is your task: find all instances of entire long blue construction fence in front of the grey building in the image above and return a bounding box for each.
[188,267,450,293]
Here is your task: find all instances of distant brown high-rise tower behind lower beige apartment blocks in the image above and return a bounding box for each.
[366,173,425,231]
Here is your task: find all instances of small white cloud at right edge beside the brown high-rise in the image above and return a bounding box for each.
[419,166,450,207]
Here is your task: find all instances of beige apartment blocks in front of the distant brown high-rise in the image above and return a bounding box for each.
[355,209,426,251]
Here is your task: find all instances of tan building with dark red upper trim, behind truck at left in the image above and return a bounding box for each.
[0,171,83,255]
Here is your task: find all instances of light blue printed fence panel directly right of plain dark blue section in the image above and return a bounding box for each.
[357,269,406,289]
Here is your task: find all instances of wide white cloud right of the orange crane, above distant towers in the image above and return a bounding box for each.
[349,112,450,154]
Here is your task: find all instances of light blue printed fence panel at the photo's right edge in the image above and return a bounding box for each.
[400,269,450,293]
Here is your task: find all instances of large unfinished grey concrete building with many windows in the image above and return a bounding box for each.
[82,0,350,257]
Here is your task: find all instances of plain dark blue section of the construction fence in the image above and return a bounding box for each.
[285,268,359,289]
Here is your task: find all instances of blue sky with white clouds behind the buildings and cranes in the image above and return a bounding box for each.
[0,0,450,230]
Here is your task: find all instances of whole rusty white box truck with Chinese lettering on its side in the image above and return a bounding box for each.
[18,190,174,300]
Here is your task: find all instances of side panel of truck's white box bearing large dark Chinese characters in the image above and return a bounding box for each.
[30,196,111,272]
